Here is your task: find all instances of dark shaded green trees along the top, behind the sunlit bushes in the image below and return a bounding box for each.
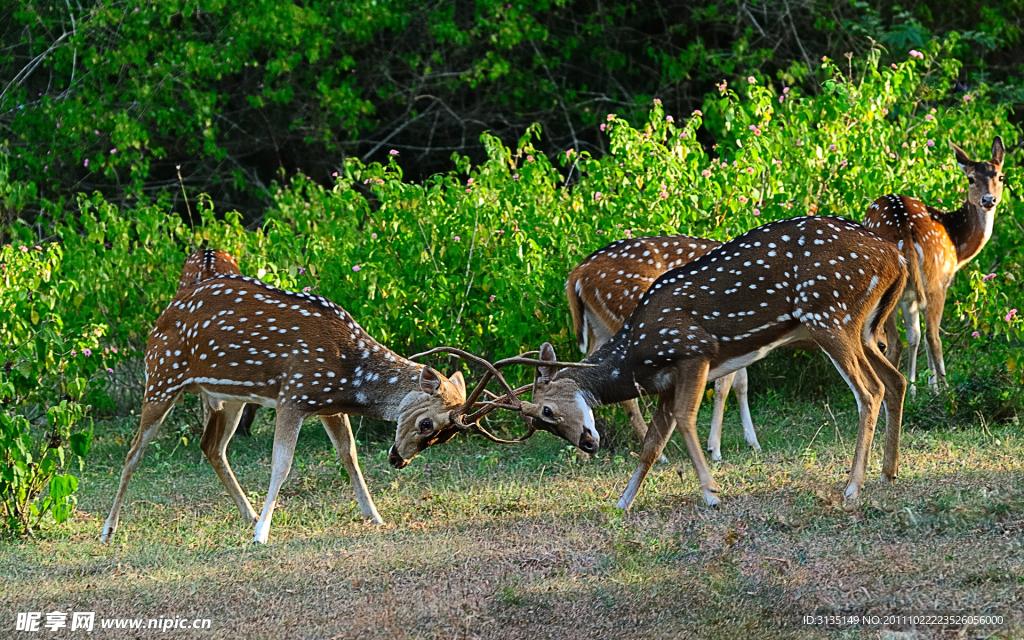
[0,0,1024,223]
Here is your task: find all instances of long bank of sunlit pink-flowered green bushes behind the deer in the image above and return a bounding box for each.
[2,51,1024,468]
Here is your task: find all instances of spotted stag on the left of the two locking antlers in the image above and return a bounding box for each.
[101,275,466,543]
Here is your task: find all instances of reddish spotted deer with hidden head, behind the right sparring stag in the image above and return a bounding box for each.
[565,236,761,462]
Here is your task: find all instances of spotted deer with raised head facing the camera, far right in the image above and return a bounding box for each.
[864,136,1006,393]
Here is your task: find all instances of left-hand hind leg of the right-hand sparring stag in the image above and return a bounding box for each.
[811,330,884,500]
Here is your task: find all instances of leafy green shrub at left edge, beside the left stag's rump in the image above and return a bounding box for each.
[0,245,107,535]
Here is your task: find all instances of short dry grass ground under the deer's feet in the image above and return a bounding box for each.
[0,356,1024,640]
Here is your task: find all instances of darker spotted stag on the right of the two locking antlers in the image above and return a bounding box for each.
[506,216,906,509]
